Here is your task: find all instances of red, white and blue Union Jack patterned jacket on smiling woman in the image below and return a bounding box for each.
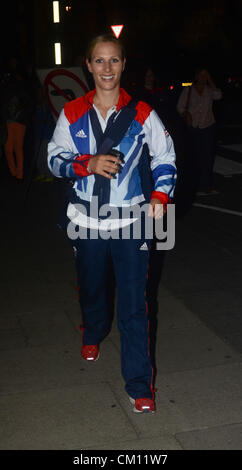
[48,88,176,207]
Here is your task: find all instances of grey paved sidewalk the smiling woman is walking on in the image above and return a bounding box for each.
[0,174,242,450]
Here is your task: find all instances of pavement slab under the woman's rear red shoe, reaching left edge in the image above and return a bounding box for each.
[0,336,124,394]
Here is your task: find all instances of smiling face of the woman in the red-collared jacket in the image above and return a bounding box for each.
[86,42,125,91]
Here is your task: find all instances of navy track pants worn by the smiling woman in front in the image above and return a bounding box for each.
[72,226,153,398]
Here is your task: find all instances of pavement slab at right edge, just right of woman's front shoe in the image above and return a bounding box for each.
[161,362,242,431]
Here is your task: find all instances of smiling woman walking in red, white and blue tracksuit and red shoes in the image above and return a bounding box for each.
[48,35,176,413]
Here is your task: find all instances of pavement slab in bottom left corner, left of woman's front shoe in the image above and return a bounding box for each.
[0,383,137,450]
